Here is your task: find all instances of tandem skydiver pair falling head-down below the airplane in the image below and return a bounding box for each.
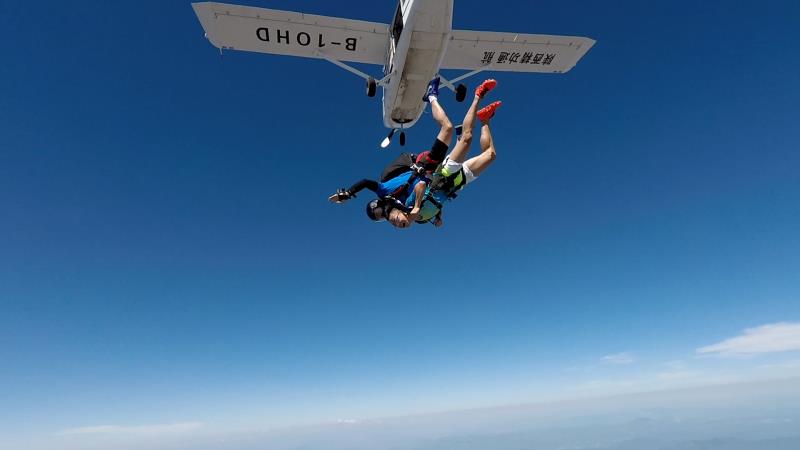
[329,78,502,228]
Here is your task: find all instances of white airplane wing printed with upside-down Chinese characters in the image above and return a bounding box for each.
[442,30,595,73]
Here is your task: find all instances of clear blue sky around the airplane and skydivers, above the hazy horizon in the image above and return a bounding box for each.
[0,0,800,446]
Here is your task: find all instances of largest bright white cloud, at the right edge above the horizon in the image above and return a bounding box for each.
[697,322,800,356]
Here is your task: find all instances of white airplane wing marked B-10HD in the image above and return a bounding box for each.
[192,2,389,64]
